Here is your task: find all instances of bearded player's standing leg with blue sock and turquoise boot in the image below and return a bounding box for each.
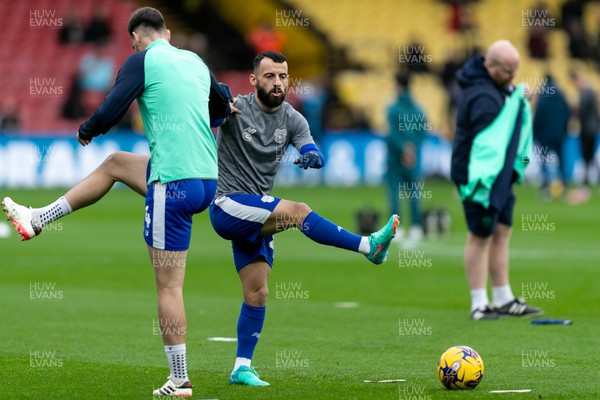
[229,257,271,386]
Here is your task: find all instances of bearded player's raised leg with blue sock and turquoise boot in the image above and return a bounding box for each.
[260,200,400,264]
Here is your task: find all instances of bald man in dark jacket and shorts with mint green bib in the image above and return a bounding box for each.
[451,40,543,320]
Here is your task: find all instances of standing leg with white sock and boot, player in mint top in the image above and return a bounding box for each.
[148,246,192,397]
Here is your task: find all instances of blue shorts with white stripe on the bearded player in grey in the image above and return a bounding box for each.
[209,194,281,271]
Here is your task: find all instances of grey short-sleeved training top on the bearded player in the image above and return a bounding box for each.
[216,93,314,197]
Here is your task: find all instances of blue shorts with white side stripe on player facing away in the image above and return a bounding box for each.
[144,179,217,251]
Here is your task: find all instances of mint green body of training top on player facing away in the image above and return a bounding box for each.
[138,39,217,183]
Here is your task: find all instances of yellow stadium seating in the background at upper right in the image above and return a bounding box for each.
[287,0,598,132]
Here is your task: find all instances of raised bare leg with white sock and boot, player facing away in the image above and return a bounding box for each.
[2,152,149,240]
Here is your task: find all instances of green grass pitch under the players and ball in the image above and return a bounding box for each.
[0,182,600,400]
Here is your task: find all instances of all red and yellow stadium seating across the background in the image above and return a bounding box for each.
[0,0,600,135]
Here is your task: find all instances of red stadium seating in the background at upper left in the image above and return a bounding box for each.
[0,0,136,135]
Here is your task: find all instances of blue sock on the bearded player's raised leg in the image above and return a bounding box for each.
[301,211,362,251]
